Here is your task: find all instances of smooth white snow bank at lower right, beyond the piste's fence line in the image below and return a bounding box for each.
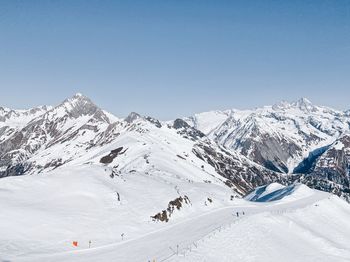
[171,193,350,262]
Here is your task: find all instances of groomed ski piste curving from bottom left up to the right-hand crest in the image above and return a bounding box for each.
[12,189,332,262]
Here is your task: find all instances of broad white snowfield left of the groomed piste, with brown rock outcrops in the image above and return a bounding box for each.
[0,144,235,261]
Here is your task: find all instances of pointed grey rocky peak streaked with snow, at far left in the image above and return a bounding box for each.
[0,94,122,177]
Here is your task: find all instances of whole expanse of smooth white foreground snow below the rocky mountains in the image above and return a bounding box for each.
[0,164,350,261]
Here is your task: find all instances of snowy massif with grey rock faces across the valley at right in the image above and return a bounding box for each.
[184,98,350,200]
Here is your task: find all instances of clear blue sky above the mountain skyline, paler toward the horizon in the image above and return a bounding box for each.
[0,0,350,119]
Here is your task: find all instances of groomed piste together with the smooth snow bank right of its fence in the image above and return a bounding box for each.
[2,181,350,261]
